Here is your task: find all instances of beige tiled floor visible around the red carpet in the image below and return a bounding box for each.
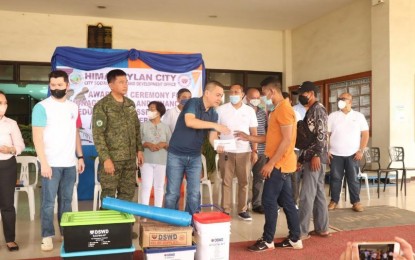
[0,177,415,260]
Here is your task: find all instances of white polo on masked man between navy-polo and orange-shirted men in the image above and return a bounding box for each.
[216,102,258,153]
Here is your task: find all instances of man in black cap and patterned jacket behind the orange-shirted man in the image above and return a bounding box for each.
[298,81,330,240]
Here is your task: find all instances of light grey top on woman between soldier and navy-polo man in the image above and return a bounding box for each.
[140,121,171,165]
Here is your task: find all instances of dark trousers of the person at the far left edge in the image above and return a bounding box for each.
[0,156,17,243]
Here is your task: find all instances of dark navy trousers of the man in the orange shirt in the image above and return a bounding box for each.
[262,168,300,243]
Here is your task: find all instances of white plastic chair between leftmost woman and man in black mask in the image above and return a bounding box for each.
[14,156,39,221]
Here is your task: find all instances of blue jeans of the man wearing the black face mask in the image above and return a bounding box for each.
[40,166,77,237]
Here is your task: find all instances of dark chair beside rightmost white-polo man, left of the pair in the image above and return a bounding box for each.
[362,147,398,198]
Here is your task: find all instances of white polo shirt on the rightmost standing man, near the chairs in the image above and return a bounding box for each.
[327,110,369,156]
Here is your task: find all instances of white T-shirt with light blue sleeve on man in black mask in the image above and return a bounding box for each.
[32,97,81,167]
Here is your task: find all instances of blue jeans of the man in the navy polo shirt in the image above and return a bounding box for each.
[164,152,202,215]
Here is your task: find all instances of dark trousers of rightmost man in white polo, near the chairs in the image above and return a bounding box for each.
[330,154,360,204]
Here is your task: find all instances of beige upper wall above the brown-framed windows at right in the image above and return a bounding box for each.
[292,0,371,84]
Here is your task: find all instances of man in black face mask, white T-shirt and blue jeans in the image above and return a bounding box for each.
[32,70,85,251]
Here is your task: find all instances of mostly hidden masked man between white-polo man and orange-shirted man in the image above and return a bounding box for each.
[246,88,268,214]
